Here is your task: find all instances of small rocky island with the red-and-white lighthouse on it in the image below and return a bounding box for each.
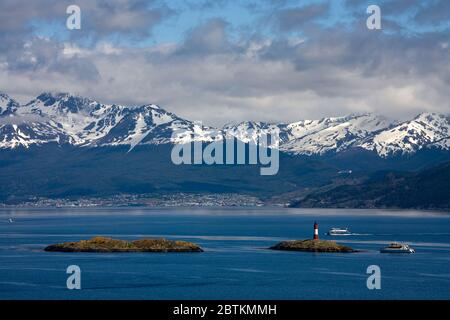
[269,239,358,253]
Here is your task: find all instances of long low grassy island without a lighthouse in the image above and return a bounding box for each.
[44,237,203,253]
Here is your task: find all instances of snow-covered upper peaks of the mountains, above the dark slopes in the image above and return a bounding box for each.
[0,93,450,157]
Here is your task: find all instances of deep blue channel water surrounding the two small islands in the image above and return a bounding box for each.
[0,208,450,299]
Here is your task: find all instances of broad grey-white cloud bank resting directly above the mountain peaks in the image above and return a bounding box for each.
[0,0,450,125]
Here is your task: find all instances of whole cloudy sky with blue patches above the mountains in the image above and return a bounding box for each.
[0,0,450,126]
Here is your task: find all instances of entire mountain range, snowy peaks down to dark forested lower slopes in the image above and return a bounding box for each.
[0,93,450,209]
